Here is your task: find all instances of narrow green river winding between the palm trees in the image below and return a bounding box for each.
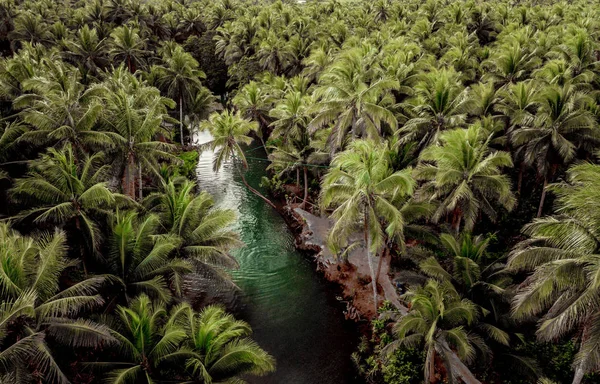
[195,132,358,384]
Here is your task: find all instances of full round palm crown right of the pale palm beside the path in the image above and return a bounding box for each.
[415,124,515,233]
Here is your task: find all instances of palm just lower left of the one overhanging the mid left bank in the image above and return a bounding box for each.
[106,212,194,302]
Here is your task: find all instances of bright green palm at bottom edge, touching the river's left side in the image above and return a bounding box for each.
[184,306,275,384]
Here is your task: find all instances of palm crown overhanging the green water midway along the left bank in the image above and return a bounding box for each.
[144,178,242,268]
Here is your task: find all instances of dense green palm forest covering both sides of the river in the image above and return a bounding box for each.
[0,0,600,384]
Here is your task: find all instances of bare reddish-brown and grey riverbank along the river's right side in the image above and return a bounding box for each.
[278,204,408,321]
